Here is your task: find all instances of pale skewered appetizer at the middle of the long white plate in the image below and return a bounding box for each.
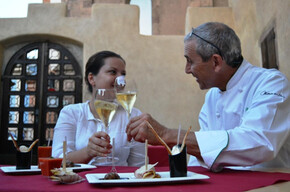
[134,162,161,179]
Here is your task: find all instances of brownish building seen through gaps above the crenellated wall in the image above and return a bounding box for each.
[62,0,229,35]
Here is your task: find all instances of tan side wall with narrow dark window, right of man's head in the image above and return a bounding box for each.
[231,0,290,79]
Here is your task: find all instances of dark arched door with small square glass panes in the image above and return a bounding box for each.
[0,42,82,164]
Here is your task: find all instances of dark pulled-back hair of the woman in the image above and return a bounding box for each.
[85,51,126,93]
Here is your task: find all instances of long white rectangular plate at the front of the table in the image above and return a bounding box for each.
[86,171,209,185]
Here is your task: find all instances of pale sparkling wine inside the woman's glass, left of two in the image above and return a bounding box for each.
[94,100,118,128]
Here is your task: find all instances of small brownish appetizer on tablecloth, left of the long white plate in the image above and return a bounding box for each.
[50,168,84,184]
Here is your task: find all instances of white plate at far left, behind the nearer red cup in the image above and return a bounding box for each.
[0,164,96,174]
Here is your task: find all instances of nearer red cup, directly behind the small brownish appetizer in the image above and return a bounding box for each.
[38,157,62,176]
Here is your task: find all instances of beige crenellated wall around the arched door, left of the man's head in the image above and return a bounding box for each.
[0,3,204,130]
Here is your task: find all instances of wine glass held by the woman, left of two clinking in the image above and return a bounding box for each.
[90,89,118,163]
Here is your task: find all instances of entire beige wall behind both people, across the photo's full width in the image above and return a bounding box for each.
[0,0,290,130]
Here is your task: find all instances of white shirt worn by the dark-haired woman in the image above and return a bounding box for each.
[52,101,145,167]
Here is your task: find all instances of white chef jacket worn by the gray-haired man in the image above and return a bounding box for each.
[189,60,290,171]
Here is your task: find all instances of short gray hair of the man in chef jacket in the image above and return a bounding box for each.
[184,22,243,68]
